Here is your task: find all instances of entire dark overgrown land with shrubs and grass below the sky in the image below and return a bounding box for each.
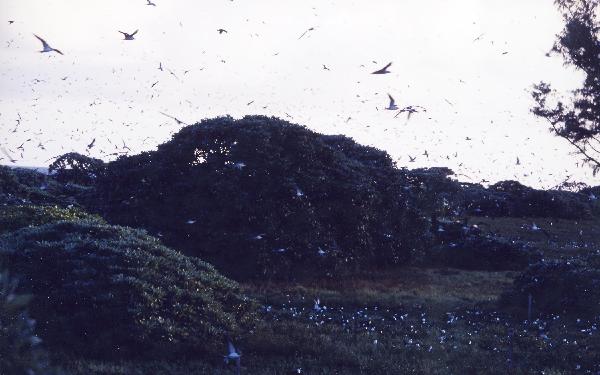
[0,116,600,375]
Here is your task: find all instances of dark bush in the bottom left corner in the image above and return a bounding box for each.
[0,271,47,375]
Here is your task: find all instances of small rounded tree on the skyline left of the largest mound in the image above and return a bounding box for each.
[48,152,105,185]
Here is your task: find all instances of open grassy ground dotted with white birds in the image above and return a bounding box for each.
[55,218,600,375]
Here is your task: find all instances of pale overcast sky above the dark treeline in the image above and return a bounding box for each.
[0,0,600,187]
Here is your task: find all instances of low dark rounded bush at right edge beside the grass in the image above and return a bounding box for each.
[503,260,600,318]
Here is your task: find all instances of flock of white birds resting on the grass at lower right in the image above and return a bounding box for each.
[252,295,600,373]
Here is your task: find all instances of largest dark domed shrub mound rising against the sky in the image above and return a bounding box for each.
[95,116,426,278]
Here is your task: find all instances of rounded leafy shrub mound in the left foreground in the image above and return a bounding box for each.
[0,221,255,357]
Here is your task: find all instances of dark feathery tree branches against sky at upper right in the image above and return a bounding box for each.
[532,0,600,174]
